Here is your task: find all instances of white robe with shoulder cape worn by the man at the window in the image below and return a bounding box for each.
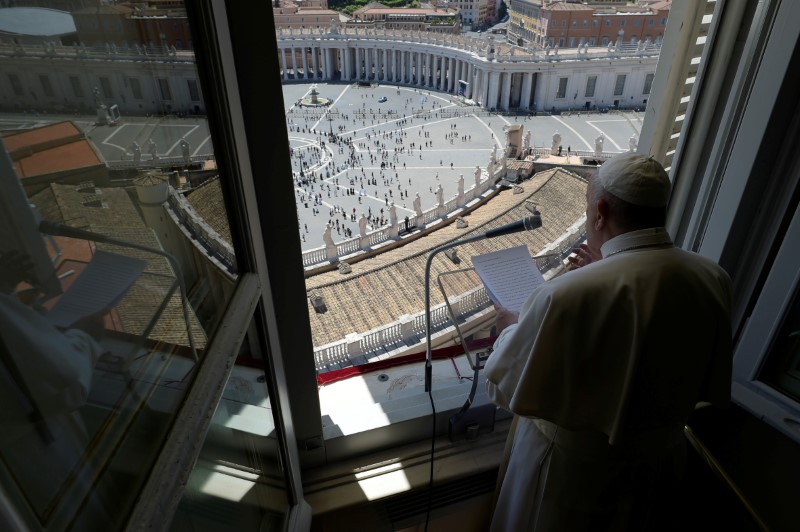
[485,228,732,532]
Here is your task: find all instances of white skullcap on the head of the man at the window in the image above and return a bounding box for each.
[597,152,671,207]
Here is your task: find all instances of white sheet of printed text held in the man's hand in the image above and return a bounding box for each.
[472,245,544,312]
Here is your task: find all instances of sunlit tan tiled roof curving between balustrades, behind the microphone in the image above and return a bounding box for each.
[306,168,586,346]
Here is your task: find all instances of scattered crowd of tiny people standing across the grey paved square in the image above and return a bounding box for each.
[286,87,482,247]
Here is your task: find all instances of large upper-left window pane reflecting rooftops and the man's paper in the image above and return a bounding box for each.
[0,2,238,530]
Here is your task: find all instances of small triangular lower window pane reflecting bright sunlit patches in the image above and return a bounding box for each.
[170,318,289,532]
